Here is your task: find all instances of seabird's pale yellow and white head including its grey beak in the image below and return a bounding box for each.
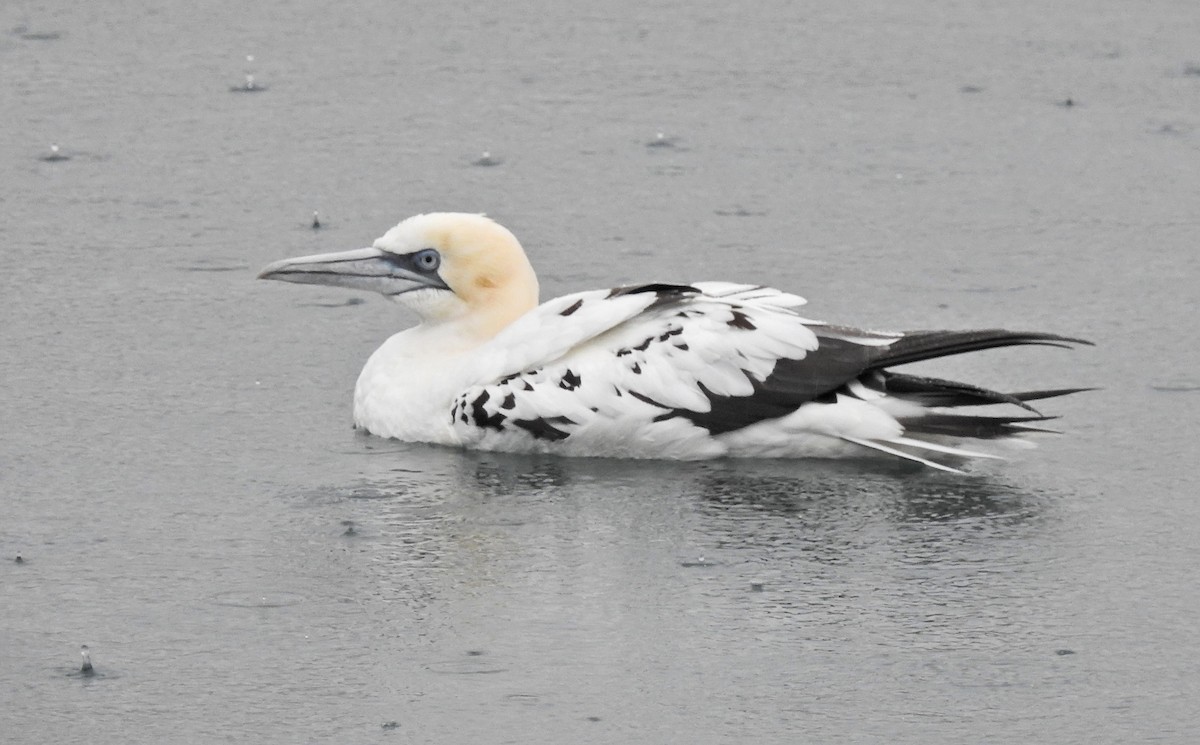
[265,212,547,337]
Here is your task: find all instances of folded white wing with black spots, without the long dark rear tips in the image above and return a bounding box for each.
[452,282,899,457]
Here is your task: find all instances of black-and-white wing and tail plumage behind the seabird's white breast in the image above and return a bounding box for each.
[446,282,1087,470]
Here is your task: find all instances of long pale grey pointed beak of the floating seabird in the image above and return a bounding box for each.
[258,248,450,295]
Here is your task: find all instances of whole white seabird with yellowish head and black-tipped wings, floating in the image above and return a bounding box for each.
[258,212,1091,473]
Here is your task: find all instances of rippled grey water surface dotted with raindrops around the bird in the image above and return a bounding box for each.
[0,0,1200,744]
